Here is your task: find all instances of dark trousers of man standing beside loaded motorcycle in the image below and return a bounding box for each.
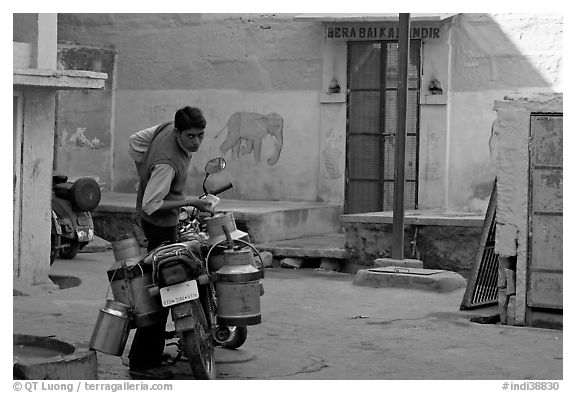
[128,220,178,370]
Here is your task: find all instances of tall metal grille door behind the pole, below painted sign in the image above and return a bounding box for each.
[345,40,420,213]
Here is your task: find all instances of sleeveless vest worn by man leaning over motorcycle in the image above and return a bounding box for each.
[136,123,190,227]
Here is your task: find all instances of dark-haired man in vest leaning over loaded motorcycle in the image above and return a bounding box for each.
[128,106,211,379]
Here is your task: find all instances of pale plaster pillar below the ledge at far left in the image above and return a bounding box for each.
[13,89,56,284]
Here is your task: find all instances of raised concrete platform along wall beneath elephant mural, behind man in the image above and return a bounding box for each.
[92,193,342,243]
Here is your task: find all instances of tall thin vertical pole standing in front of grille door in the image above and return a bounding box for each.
[392,14,410,260]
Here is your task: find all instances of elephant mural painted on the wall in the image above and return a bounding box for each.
[216,112,284,165]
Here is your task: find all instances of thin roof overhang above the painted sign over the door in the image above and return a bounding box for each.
[294,13,458,23]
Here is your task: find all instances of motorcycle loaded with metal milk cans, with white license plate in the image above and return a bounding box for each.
[91,158,264,379]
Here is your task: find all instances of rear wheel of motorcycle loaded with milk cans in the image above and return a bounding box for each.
[179,300,216,379]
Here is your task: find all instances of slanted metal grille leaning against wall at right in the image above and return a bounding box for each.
[460,181,498,310]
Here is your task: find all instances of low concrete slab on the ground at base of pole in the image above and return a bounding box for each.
[354,266,466,292]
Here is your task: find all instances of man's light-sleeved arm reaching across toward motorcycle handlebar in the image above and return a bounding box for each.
[142,164,212,215]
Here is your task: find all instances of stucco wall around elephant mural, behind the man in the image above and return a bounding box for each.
[59,14,323,200]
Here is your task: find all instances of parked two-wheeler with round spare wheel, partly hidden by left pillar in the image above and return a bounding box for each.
[50,173,102,265]
